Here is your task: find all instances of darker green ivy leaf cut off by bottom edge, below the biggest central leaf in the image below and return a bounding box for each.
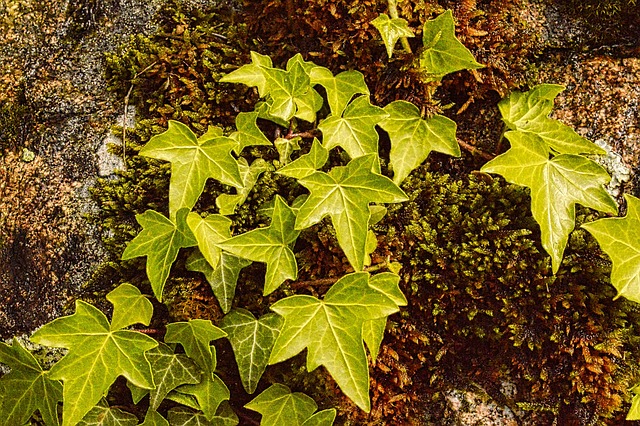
[245,383,336,426]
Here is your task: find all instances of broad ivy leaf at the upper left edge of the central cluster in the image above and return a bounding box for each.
[140,120,242,217]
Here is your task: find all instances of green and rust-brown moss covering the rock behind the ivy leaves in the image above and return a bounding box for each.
[85,0,639,425]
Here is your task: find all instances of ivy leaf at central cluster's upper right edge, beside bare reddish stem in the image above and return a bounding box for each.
[379,101,460,185]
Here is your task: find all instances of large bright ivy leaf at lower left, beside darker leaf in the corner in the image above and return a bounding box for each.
[31,282,158,426]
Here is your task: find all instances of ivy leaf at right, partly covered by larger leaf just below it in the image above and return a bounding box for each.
[498,84,606,154]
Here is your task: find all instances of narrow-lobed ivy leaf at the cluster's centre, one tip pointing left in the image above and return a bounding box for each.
[219,195,300,296]
